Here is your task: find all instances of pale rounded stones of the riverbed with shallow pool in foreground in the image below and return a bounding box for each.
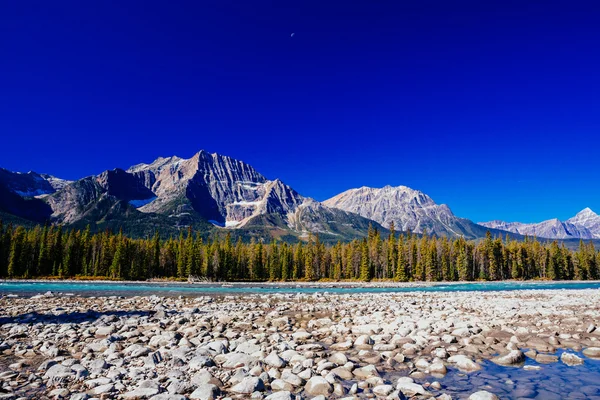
[0,290,600,400]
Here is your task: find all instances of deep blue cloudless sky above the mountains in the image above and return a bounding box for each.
[0,0,600,222]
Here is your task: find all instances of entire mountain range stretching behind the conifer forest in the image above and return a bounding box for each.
[0,151,600,242]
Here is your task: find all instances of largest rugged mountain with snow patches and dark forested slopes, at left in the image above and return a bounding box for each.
[0,151,383,240]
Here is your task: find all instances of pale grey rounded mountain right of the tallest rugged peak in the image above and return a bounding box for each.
[323,186,498,238]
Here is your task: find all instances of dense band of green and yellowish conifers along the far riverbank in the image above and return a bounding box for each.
[0,221,600,281]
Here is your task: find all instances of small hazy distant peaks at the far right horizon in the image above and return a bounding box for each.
[480,208,600,239]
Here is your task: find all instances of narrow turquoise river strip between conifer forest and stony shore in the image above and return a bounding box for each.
[0,281,600,296]
